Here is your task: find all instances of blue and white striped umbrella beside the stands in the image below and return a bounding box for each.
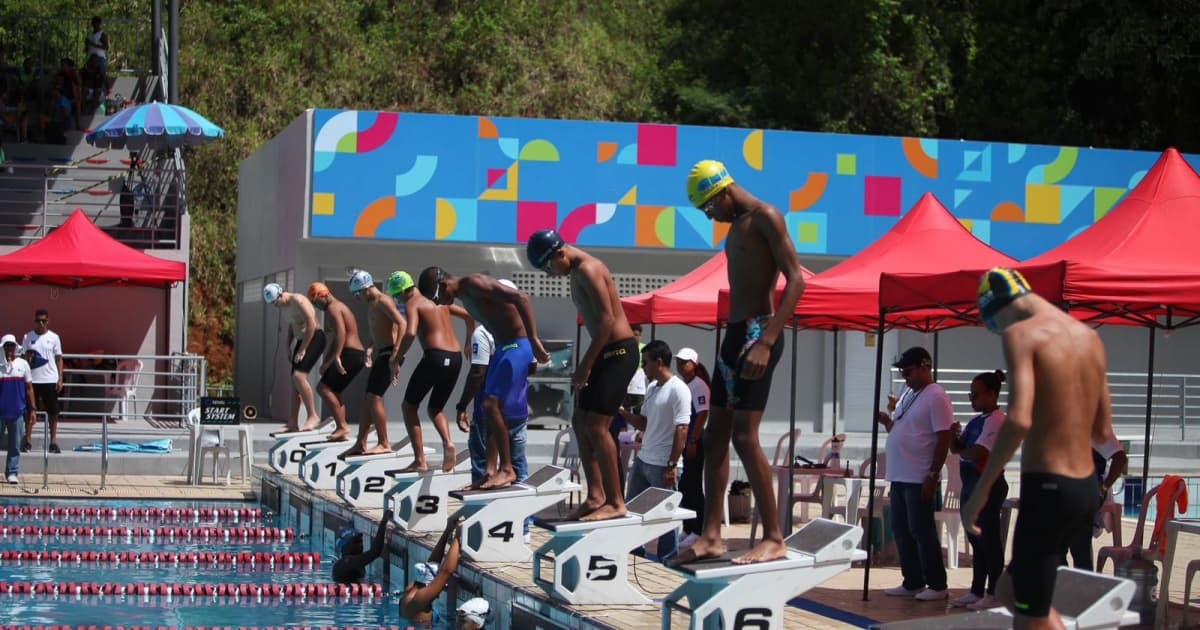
[88,103,224,150]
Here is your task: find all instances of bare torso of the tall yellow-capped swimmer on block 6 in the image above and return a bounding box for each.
[725,203,786,322]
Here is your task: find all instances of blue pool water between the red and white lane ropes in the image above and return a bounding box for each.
[0,499,409,628]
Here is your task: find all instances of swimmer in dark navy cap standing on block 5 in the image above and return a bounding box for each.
[526,229,638,521]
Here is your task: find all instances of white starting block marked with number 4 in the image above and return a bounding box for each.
[450,466,580,562]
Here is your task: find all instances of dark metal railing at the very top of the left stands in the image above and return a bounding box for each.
[0,16,154,74]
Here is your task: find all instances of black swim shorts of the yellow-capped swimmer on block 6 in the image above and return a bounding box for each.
[709,316,784,412]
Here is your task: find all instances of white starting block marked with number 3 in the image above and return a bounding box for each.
[384,451,470,532]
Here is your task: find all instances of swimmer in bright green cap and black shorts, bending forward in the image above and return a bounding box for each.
[388,271,475,473]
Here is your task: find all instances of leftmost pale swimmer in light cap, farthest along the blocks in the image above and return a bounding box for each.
[263,282,325,431]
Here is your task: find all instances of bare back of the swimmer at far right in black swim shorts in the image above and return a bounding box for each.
[1004,295,1112,479]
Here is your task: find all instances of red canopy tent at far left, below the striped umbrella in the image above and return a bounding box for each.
[0,209,187,288]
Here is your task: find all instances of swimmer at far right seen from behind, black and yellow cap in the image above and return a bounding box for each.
[962,268,1112,629]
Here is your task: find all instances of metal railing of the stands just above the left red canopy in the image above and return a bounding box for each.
[0,150,186,248]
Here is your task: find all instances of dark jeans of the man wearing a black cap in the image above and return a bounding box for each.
[889,481,946,590]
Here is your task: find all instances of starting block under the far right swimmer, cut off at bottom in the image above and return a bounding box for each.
[871,566,1141,630]
